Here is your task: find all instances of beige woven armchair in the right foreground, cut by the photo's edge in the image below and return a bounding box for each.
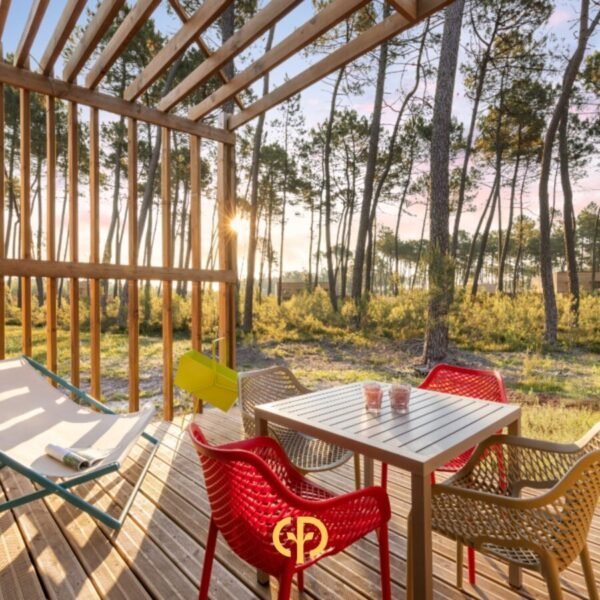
[409,423,600,600]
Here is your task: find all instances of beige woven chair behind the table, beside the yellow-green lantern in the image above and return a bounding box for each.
[238,366,360,489]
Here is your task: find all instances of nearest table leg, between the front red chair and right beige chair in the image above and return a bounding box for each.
[407,473,433,600]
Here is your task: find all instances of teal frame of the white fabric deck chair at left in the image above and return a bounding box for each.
[0,356,159,529]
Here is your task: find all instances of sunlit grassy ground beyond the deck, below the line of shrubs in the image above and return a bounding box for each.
[7,326,600,440]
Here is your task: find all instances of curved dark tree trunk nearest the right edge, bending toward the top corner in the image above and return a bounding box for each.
[539,0,600,344]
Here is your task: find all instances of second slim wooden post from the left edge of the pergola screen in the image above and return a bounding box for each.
[19,88,32,356]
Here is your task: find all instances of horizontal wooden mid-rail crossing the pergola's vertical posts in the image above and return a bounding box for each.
[0,258,236,283]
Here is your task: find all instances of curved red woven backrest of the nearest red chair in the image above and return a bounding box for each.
[188,424,318,575]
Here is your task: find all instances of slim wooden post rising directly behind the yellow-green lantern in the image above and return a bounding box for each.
[190,135,202,413]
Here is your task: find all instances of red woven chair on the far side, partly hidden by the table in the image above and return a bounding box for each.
[419,364,508,585]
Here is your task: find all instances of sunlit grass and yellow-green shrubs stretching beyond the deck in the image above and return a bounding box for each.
[6,290,600,441]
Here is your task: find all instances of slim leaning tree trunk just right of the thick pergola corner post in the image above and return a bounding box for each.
[242,27,275,333]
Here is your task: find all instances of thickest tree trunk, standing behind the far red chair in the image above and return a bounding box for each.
[423,0,465,364]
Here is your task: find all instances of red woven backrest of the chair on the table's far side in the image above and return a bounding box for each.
[419,363,508,402]
